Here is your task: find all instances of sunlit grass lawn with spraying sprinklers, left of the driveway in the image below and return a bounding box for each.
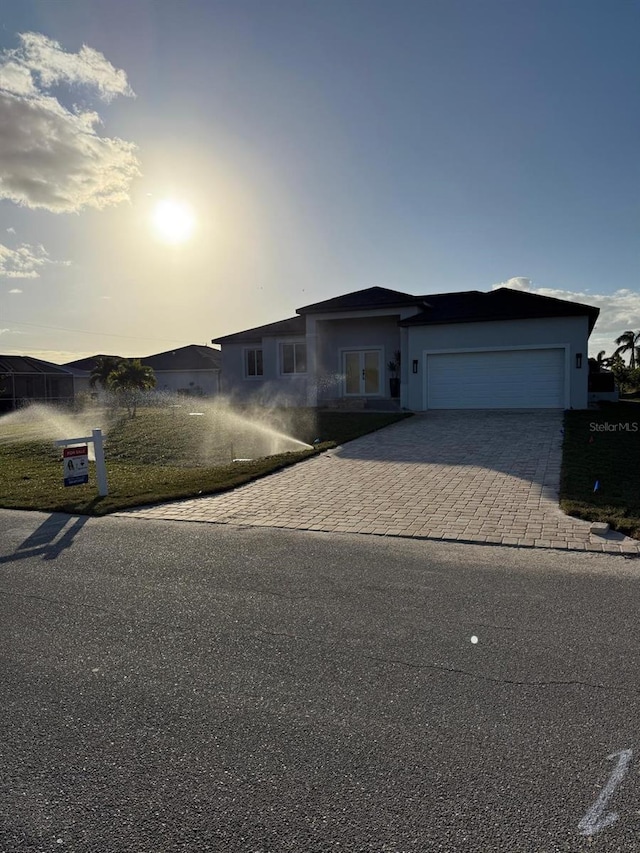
[0,402,408,515]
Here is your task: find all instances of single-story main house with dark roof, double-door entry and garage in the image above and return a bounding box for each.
[212,287,599,411]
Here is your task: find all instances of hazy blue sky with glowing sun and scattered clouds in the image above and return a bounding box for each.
[0,0,640,363]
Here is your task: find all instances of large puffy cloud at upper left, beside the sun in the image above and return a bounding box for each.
[0,33,139,213]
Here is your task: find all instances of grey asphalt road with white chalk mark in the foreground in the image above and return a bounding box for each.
[0,511,640,853]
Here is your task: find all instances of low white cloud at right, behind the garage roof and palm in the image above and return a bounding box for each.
[492,276,640,355]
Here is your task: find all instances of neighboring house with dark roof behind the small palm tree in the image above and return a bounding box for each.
[65,344,221,396]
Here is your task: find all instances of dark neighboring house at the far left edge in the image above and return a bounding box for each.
[0,355,74,412]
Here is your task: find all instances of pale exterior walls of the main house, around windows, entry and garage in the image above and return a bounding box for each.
[221,309,589,411]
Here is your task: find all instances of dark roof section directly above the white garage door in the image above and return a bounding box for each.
[400,287,600,333]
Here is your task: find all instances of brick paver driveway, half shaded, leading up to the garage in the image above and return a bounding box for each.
[120,411,640,553]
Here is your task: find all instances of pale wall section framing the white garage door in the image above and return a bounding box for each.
[402,317,589,411]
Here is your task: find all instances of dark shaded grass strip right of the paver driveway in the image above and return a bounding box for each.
[560,400,640,539]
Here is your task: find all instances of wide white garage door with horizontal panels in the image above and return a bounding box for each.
[425,349,565,409]
